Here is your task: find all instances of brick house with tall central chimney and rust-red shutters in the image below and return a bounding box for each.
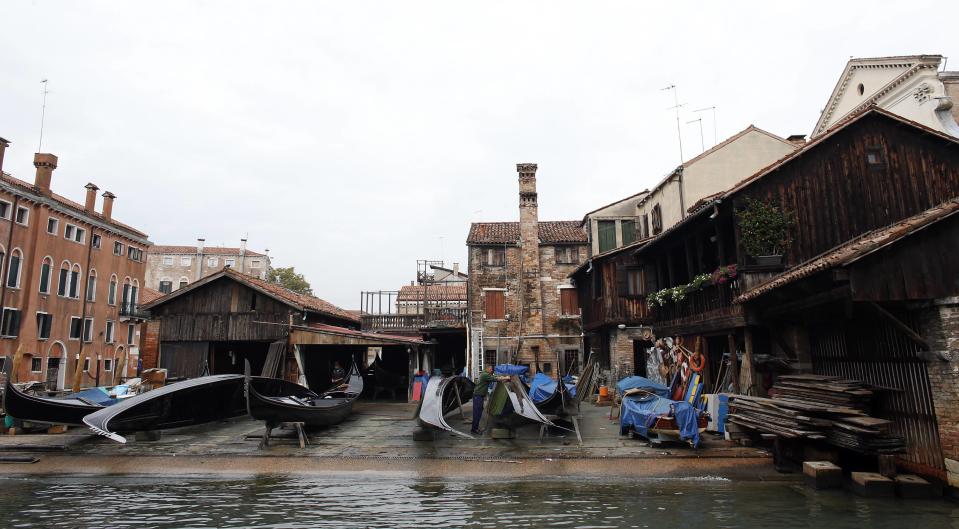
[466,163,587,376]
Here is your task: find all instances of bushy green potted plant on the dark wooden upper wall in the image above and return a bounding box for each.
[736,197,795,266]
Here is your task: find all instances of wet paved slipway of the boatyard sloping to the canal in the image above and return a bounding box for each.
[0,402,782,480]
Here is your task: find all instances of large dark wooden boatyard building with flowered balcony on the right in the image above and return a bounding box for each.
[577,108,959,485]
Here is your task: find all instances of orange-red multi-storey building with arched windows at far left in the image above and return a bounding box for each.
[0,139,151,388]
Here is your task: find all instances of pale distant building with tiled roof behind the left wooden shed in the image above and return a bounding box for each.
[146,239,270,294]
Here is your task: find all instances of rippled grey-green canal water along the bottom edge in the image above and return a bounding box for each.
[0,476,959,529]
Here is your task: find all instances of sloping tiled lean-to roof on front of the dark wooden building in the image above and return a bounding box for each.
[735,198,959,303]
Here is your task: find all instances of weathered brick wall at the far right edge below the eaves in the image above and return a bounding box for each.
[920,297,959,487]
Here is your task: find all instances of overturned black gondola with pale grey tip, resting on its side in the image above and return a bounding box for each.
[83,375,251,443]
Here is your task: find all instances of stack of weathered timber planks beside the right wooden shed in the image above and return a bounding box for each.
[728,375,905,454]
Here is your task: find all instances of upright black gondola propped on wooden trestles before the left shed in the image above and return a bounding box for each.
[245,364,363,429]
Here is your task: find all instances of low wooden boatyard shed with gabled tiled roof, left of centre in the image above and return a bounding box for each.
[144,268,427,396]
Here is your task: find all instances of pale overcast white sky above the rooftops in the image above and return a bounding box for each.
[0,0,959,308]
